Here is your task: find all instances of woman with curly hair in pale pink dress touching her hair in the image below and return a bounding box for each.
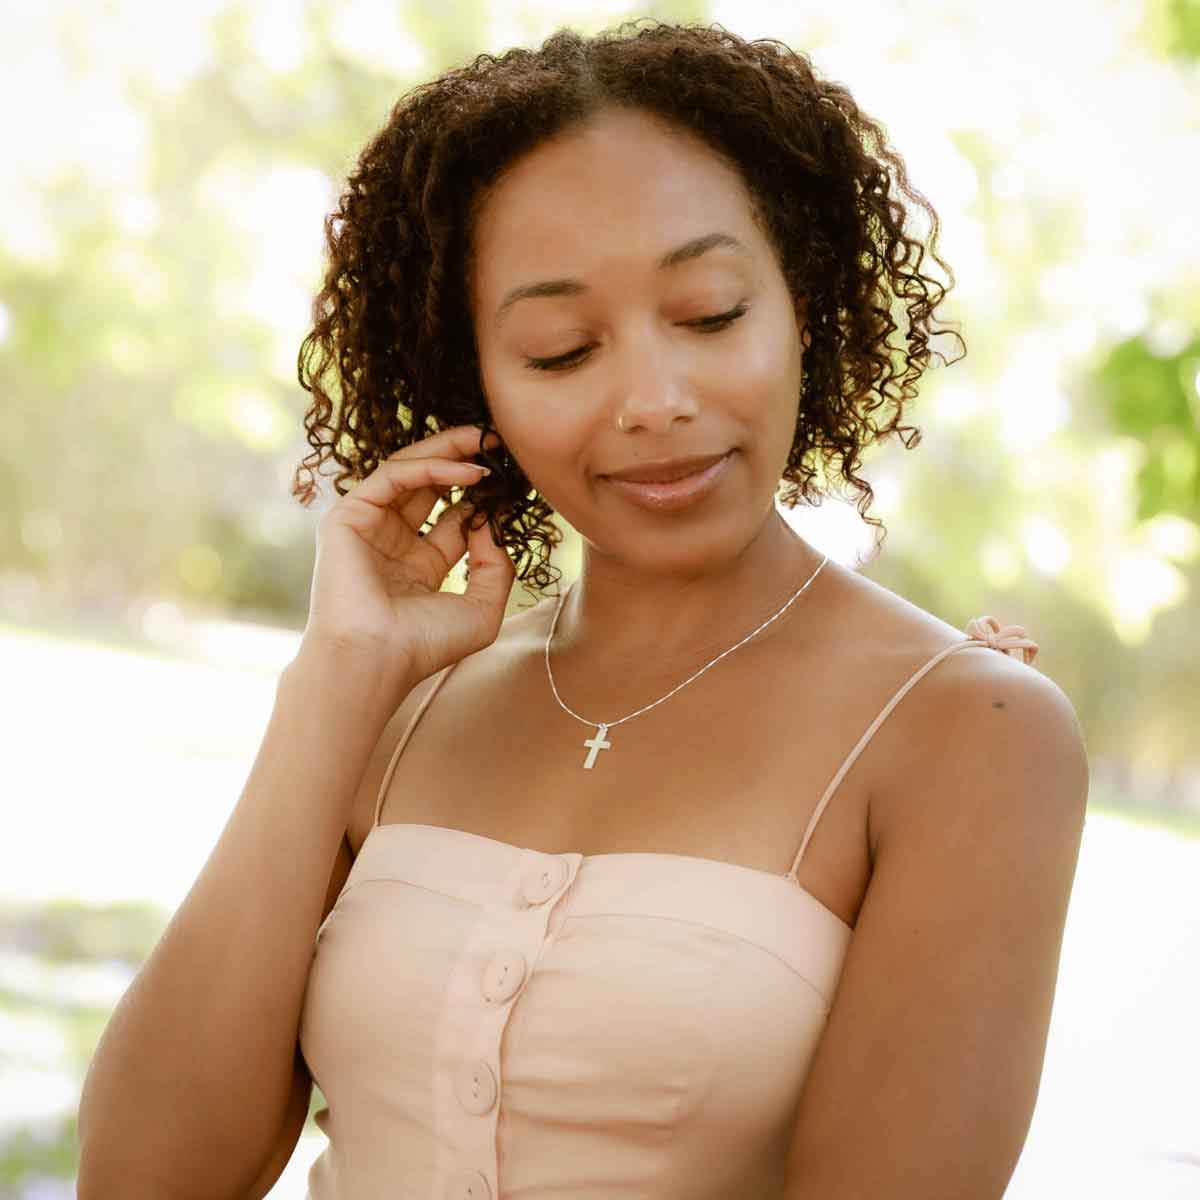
[72,16,1087,1200]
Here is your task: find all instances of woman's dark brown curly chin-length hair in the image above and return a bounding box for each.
[292,18,966,600]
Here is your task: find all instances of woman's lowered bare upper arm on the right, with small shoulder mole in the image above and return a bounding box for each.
[786,650,1087,1200]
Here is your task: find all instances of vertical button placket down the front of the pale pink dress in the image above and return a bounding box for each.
[433,850,582,1200]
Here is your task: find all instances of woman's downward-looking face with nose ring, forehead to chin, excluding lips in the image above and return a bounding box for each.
[470,109,803,572]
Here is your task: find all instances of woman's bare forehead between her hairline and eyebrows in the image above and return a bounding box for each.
[473,110,764,304]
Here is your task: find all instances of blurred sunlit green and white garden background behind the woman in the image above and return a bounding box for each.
[0,0,1200,1200]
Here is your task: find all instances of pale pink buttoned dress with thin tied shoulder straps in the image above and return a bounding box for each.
[300,617,1037,1200]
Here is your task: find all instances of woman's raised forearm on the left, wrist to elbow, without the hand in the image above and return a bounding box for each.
[78,648,412,1200]
